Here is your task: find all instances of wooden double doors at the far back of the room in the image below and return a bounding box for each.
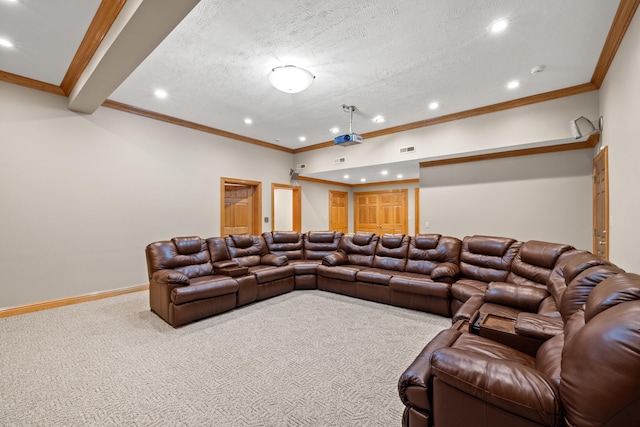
[354,189,408,234]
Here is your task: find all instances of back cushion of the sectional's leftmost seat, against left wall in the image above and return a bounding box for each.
[145,236,213,279]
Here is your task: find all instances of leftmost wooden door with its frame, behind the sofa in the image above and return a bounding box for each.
[220,178,262,236]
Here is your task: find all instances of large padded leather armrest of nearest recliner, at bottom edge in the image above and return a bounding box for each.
[431,348,562,425]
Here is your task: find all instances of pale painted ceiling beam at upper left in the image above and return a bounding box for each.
[69,0,200,114]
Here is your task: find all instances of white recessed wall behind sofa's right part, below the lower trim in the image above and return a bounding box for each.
[420,149,593,250]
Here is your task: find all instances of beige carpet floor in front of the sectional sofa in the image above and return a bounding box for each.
[0,291,450,427]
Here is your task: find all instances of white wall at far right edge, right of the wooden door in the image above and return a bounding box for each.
[600,12,640,273]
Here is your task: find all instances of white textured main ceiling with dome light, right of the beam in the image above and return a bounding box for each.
[110,0,618,149]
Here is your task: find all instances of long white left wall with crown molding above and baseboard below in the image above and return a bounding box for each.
[0,82,292,307]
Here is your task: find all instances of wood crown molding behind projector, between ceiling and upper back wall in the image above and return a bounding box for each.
[293,83,598,154]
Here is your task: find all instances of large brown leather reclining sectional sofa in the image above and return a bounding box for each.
[146,231,640,427]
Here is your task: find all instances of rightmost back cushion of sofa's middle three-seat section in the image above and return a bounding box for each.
[405,234,462,275]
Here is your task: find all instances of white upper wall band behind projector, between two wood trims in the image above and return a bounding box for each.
[295,91,599,175]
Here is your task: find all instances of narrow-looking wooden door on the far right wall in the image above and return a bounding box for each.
[593,147,609,259]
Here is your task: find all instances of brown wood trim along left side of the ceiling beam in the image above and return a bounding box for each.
[60,0,127,96]
